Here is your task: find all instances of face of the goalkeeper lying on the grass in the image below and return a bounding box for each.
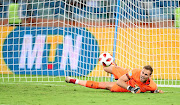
[140,69,151,82]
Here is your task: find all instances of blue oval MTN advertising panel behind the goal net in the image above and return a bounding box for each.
[2,27,99,76]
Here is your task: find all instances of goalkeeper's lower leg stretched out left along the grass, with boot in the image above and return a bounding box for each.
[65,77,115,90]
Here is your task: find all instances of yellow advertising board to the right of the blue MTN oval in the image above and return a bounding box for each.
[88,28,180,79]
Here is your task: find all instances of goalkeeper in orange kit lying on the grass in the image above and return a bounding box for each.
[65,63,163,93]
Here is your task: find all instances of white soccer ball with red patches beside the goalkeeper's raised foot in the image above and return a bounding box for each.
[99,53,113,67]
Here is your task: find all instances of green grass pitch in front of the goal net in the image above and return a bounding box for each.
[0,75,180,105]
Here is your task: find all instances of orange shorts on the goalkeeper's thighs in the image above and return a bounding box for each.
[110,66,130,92]
